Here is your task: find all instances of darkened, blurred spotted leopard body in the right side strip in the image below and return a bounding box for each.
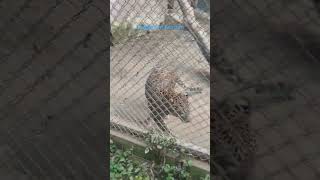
[210,97,257,180]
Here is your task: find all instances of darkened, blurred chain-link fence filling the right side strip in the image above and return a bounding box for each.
[211,0,320,180]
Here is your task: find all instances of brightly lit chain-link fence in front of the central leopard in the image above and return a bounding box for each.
[110,0,210,160]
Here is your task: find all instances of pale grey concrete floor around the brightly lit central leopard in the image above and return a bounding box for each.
[111,31,210,157]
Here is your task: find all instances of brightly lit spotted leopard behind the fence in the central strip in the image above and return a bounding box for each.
[145,66,201,133]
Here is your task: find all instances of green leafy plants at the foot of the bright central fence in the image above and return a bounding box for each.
[110,131,210,180]
